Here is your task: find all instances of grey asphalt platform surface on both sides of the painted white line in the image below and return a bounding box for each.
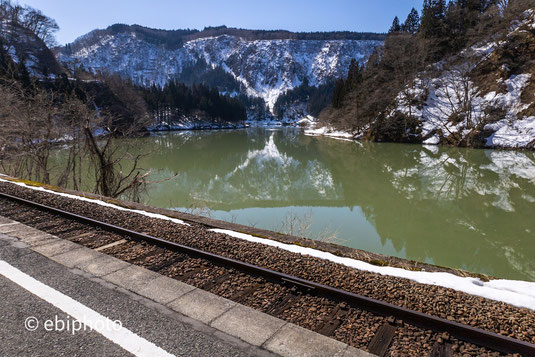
[0,234,267,356]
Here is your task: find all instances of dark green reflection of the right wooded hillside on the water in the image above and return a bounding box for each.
[318,144,535,280]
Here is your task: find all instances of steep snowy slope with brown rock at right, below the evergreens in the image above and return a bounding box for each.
[391,10,535,148]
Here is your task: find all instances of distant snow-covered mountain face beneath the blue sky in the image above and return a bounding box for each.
[58,25,382,107]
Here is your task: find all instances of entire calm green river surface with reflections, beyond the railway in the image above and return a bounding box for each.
[51,128,535,281]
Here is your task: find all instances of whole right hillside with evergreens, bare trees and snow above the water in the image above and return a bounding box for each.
[321,0,535,148]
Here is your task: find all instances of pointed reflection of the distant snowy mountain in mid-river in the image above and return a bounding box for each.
[196,134,341,204]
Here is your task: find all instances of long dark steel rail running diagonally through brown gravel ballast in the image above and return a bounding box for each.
[0,192,535,356]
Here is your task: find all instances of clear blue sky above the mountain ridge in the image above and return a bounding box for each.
[19,0,423,44]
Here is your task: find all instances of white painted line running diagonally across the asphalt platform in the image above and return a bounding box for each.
[0,260,175,357]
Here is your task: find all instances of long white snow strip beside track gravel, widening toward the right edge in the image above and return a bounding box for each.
[210,229,535,310]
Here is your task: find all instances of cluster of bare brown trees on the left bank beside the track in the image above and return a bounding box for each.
[0,78,154,200]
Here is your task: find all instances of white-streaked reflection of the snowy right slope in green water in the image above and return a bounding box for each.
[392,148,535,212]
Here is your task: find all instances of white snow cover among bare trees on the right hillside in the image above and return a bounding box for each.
[391,10,535,148]
